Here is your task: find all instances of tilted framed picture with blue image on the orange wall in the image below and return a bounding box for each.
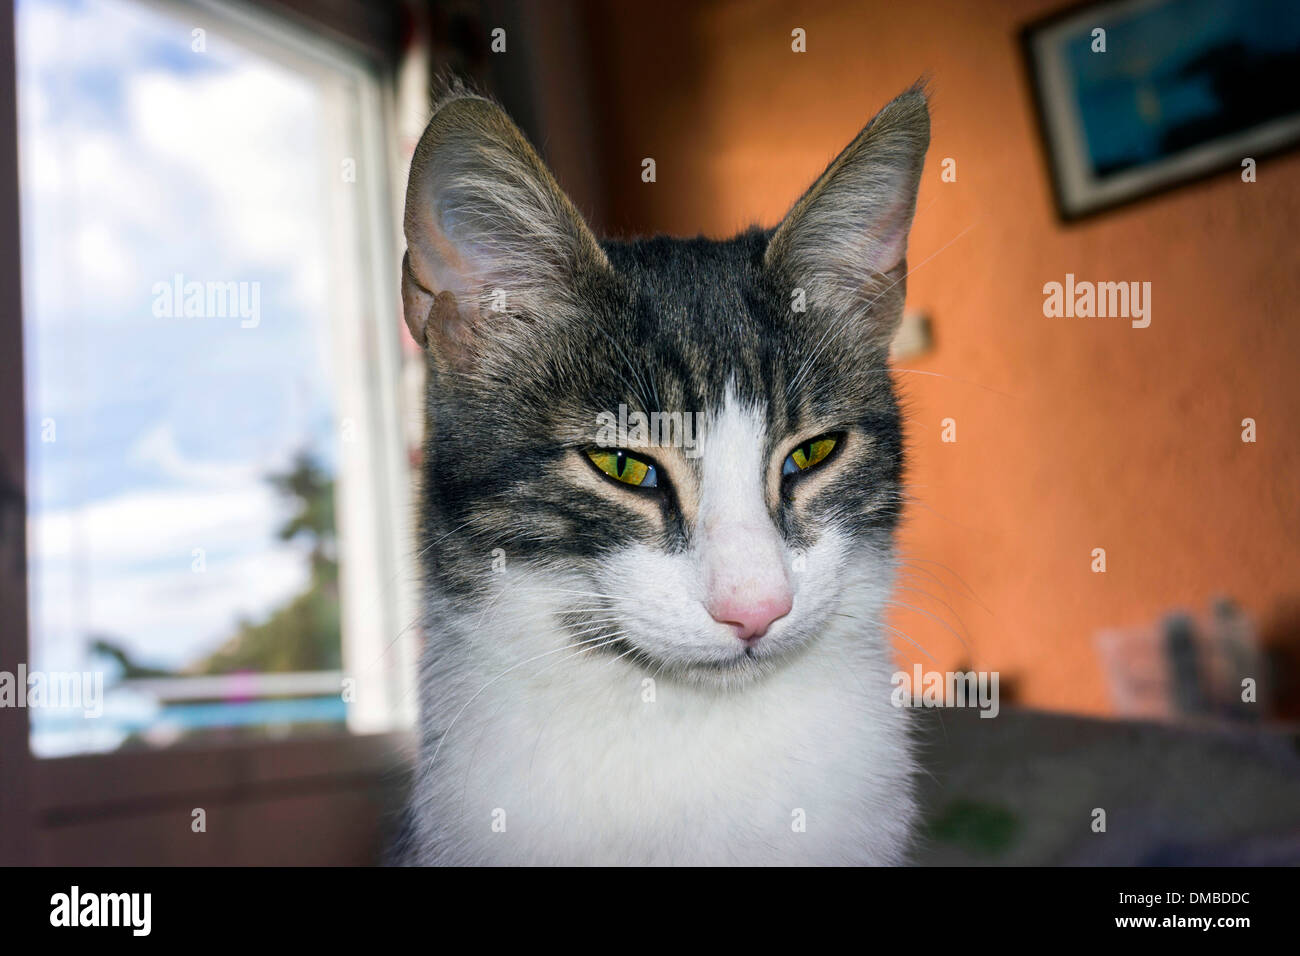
[1022,0,1300,220]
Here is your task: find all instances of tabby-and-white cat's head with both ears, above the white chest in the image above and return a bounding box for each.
[403,90,930,683]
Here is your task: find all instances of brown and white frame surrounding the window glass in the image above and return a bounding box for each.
[0,0,416,865]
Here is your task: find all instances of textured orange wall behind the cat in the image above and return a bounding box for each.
[572,0,1300,713]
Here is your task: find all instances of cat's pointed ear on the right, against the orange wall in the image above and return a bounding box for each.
[764,87,930,345]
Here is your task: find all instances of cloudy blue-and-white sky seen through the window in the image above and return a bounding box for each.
[17,0,335,670]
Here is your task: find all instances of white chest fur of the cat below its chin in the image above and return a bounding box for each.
[417,621,913,865]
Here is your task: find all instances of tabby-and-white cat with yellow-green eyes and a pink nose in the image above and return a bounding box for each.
[402,87,930,865]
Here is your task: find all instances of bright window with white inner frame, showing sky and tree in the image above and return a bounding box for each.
[16,0,415,757]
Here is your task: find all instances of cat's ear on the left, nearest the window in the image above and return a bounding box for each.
[402,95,608,365]
